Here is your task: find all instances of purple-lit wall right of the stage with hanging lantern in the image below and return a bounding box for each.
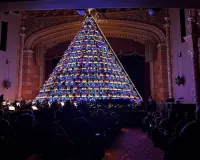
[170,9,193,103]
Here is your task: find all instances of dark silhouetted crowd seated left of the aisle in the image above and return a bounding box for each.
[0,102,122,160]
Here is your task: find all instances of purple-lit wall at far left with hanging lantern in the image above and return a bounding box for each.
[0,14,21,100]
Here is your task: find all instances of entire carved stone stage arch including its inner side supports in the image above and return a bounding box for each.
[22,20,168,100]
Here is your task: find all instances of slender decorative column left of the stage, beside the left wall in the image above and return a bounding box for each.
[17,19,26,99]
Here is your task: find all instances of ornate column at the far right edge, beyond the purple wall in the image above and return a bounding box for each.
[184,9,200,104]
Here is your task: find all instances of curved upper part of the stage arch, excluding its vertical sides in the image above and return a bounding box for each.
[25,20,165,49]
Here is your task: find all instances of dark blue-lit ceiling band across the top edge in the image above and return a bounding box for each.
[0,0,199,12]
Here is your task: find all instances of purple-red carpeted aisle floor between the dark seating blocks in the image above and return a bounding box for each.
[105,129,163,160]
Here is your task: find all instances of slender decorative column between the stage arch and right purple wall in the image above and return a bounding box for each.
[165,9,173,98]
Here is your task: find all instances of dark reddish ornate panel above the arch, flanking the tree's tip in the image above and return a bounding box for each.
[21,9,164,38]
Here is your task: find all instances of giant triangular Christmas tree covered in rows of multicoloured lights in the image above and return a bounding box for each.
[36,16,142,103]
